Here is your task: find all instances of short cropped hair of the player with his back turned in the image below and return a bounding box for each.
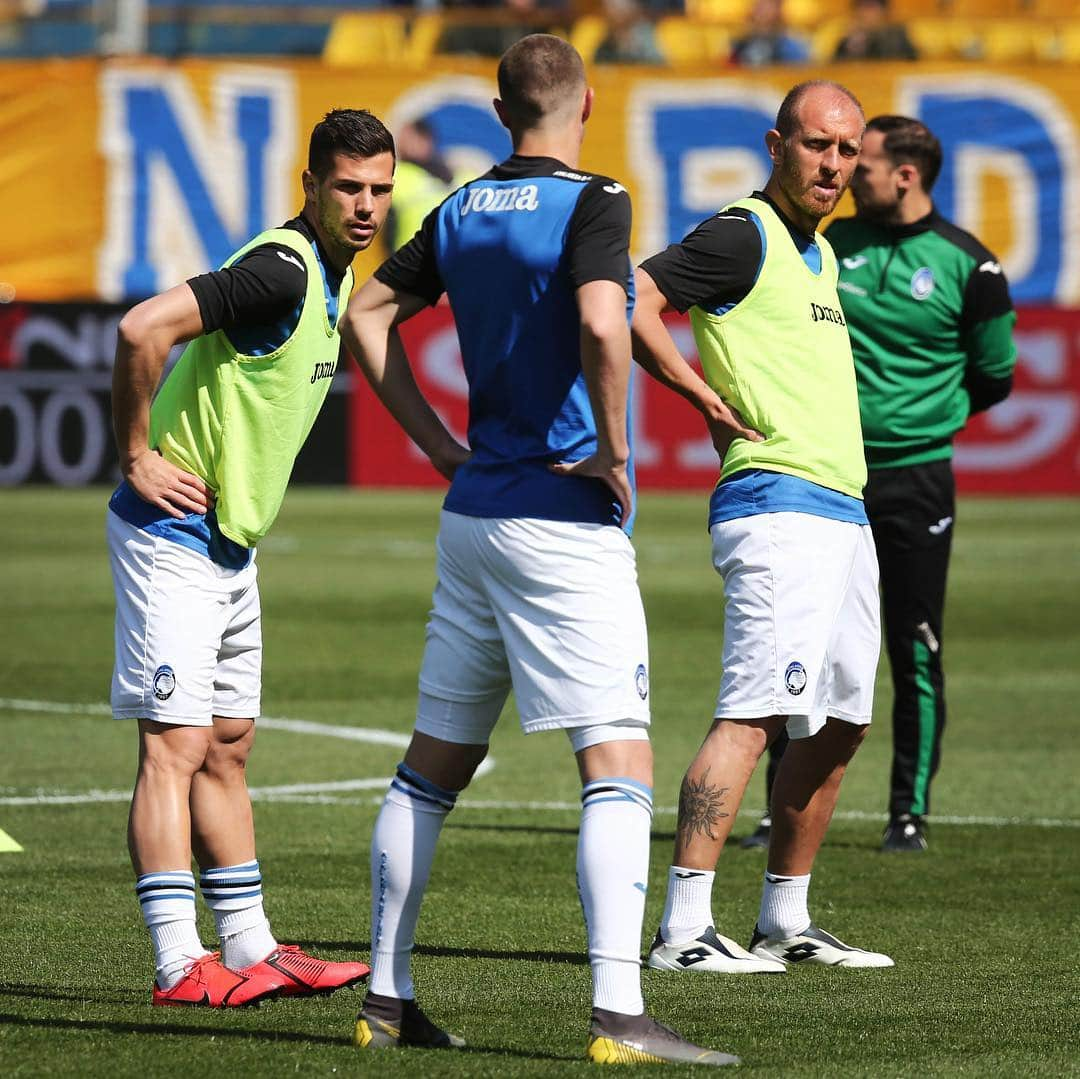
[498,33,585,127]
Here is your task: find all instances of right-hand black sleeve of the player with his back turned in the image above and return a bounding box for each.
[566,176,631,292]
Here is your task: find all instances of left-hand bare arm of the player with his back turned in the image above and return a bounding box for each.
[340,278,469,480]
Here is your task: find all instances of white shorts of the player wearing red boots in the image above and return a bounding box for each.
[106,511,262,727]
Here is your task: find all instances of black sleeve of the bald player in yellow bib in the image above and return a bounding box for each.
[642,208,764,311]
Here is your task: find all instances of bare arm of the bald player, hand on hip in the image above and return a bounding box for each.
[631,267,764,459]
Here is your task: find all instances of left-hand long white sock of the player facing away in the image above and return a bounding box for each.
[368,764,458,1000]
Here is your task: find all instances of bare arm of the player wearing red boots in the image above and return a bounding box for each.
[112,284,214,517]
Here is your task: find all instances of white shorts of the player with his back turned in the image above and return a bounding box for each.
[417,510,649,744]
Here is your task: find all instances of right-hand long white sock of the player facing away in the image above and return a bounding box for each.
[578,777,652,1015]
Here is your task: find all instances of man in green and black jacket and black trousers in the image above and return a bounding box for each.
[756,116,1016,851]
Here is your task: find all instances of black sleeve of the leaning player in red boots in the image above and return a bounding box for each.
[188,244,308,334]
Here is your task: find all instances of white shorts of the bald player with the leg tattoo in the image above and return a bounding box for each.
[711,513,880,738]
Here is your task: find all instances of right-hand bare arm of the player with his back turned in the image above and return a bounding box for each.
[551,281,633,524]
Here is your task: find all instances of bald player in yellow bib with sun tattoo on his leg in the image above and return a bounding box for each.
[633,81,892,973]
